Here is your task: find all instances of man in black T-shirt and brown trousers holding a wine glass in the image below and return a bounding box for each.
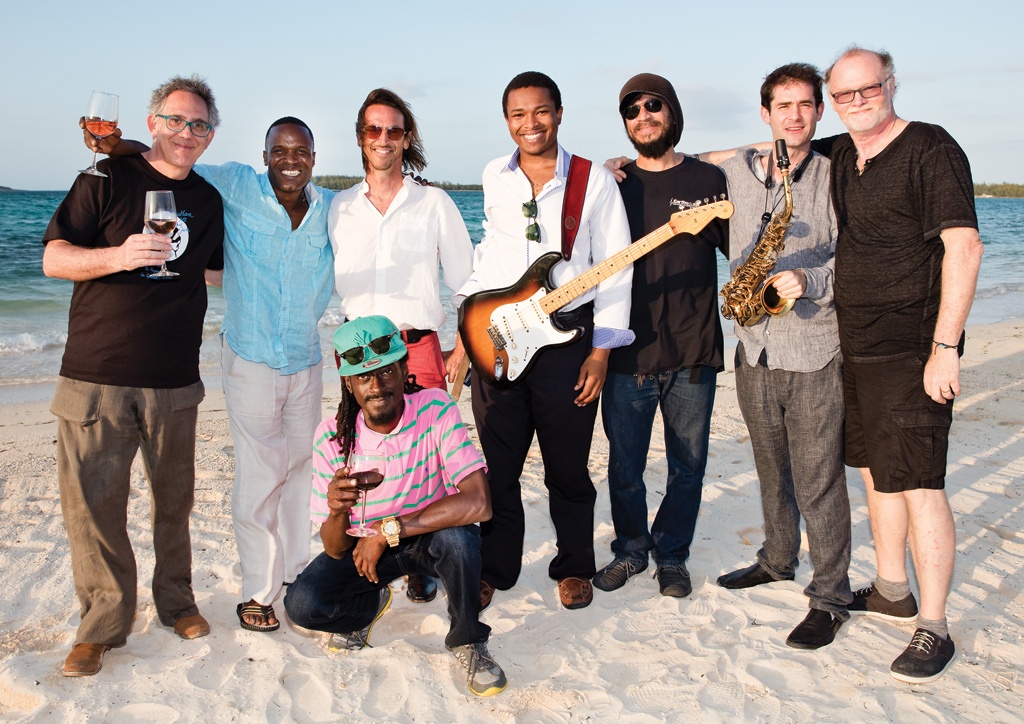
[43,76,224,676]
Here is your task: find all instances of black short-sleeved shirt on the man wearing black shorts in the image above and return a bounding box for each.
[814,122,978,361]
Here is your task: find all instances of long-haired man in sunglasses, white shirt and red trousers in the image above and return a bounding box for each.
[328,88,473,602]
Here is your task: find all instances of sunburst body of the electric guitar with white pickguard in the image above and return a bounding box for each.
[459,252,583,388]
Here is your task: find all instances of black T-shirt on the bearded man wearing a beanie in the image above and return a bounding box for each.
[608,156,729,375]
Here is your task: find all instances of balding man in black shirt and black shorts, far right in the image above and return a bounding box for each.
[825,48,982,683]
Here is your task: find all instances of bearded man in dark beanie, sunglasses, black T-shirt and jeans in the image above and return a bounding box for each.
[593,73,728,598]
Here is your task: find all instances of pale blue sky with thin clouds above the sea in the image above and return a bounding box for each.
[0,0,1024,189]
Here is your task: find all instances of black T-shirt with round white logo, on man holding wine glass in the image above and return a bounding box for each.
[43,156,224,388]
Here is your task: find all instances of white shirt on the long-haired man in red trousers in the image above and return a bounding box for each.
[328,177,473,330]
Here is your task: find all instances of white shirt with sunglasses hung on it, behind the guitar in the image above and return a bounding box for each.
[458,145,633,333]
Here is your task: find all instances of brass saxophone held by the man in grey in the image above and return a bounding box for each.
[720,138,796,327]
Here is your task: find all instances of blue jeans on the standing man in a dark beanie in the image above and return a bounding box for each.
[601,367,718,565]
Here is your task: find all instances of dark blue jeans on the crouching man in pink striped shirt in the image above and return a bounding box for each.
[285,525,490,648]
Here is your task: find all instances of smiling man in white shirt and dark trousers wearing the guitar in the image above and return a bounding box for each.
[459,72,633,608]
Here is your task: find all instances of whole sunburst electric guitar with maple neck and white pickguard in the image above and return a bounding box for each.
[459,201,732,388]
